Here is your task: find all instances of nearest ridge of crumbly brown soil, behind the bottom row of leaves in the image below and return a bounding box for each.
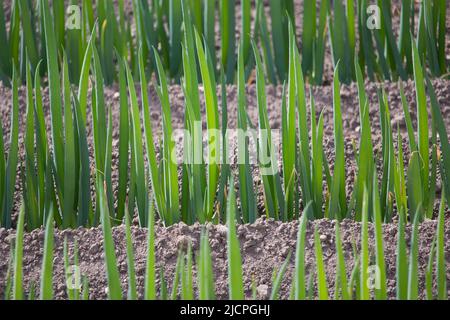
[0,212,450,299]
